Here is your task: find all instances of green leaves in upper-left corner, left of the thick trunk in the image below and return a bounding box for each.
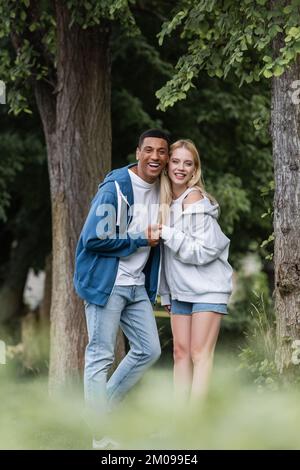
[0,0,56,115]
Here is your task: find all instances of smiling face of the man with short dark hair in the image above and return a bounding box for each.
[136,137,169,183]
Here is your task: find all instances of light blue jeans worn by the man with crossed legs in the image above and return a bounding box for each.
[84,286,161,415]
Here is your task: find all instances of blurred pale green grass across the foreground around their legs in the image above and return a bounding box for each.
[0,348,300,450]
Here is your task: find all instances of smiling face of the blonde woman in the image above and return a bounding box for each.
[168,147,195,186]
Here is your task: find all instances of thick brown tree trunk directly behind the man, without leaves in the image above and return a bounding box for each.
[36,0,111,393]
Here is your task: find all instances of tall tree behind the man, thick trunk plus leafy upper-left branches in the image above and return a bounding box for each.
[0,0,135,390]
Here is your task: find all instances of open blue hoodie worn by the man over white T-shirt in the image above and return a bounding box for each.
[74,164,160,306]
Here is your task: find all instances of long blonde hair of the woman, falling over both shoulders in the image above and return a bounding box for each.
[159,139,217,224]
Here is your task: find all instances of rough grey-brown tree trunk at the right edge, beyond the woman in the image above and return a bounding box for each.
[271,46,300,372]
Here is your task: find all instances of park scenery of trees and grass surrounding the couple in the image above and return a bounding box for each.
[0,0,300,449]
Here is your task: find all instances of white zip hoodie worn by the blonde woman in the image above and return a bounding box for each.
[159,188,232,305]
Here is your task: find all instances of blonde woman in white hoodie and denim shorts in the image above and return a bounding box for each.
[159,140,232,399]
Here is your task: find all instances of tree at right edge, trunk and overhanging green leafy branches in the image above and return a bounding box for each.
[157,0,300,372]
